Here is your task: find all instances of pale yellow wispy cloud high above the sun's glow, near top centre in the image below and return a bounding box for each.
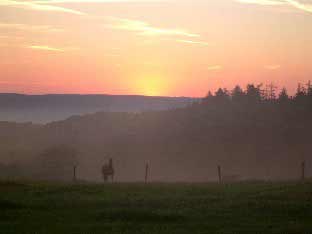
[106,17,200,37]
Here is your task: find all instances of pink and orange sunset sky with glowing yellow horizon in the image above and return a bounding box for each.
[0,0,312,97]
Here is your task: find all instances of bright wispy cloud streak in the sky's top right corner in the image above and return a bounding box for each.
[234,0,312,13]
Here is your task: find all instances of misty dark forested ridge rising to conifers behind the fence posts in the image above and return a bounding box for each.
[0,83,312,181]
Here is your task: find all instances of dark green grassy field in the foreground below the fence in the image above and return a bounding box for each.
[0,182,312,234]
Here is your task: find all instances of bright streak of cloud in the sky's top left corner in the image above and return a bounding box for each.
[0,0,86,15]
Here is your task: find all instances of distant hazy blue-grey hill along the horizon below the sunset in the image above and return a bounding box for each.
[0,93,198,123]
